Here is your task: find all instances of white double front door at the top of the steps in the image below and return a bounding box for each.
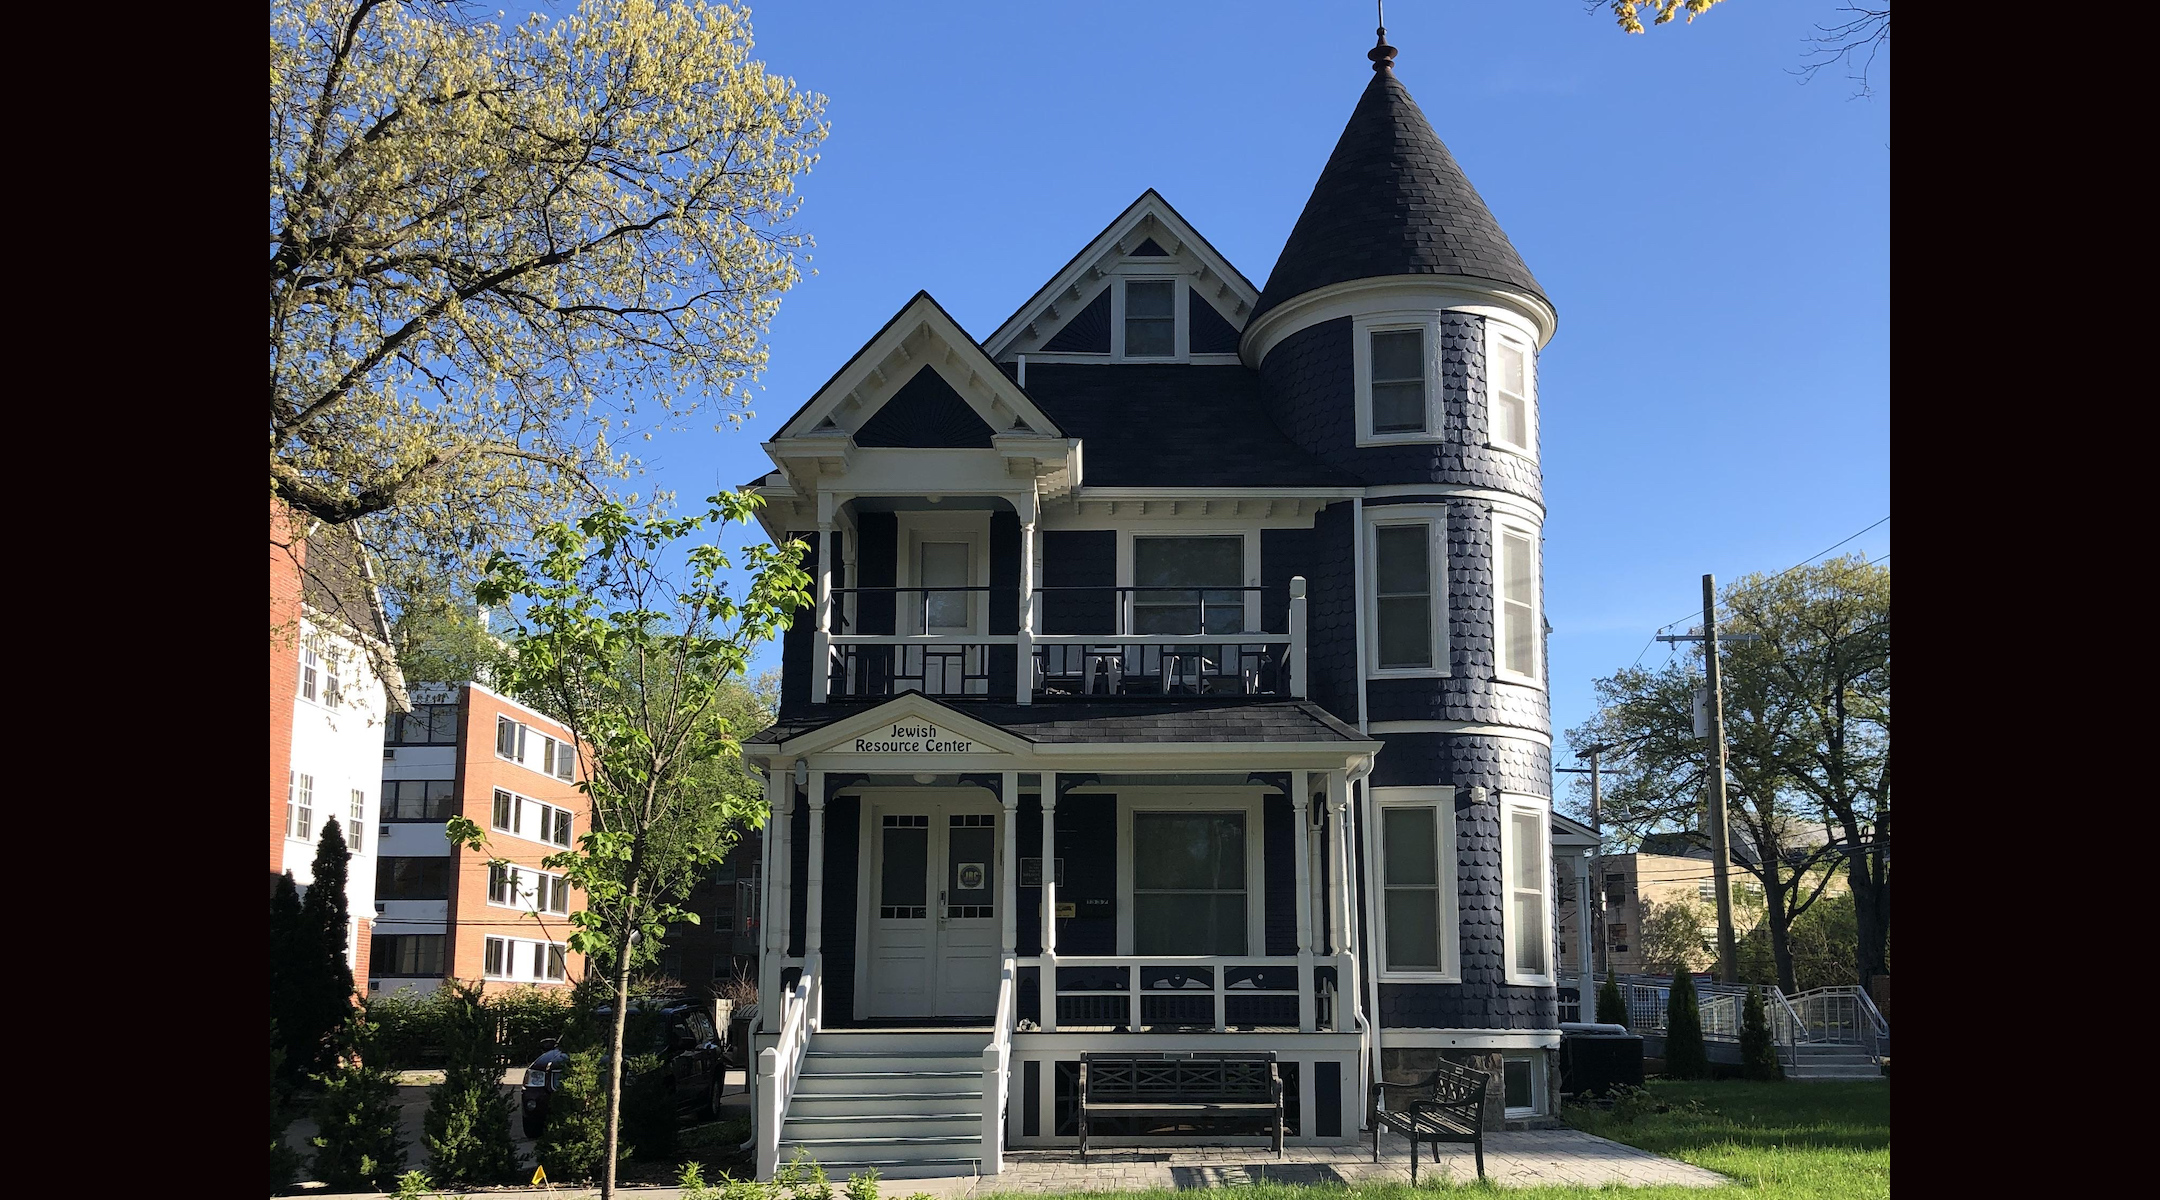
[864,792,1007,1019]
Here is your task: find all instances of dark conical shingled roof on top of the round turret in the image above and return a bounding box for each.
[1253,71,1544,319]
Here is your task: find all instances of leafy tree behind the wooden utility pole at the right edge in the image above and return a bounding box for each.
[1568,557,1890,993]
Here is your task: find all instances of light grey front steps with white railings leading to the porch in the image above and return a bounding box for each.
[780,1029,989,1183]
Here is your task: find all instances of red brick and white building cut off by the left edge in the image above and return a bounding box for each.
[270,501,402,980]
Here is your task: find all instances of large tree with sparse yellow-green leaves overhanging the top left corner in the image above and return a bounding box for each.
[268,0,825,664]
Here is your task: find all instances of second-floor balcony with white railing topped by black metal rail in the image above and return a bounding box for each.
[814,576,1305,704]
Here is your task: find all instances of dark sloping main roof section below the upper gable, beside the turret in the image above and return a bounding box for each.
[1006,363,1359,488]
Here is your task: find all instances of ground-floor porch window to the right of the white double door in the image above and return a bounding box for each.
[1132,812,1248,954]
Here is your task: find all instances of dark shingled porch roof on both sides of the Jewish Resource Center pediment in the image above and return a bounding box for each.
[750,699,1365,745]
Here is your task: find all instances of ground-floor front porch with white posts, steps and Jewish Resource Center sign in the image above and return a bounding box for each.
[747,695,1378,1176]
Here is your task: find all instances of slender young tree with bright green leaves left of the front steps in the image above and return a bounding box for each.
[449,492,810,1200]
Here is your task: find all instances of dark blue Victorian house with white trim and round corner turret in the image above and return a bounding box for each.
[745,32,1560,1176]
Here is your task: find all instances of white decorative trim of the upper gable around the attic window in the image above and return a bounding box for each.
[983,188,1259,363]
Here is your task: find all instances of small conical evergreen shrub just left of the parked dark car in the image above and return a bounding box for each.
[421,980,518,1185]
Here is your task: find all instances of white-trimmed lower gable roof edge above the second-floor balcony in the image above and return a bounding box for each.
[773,291,1065,442]
